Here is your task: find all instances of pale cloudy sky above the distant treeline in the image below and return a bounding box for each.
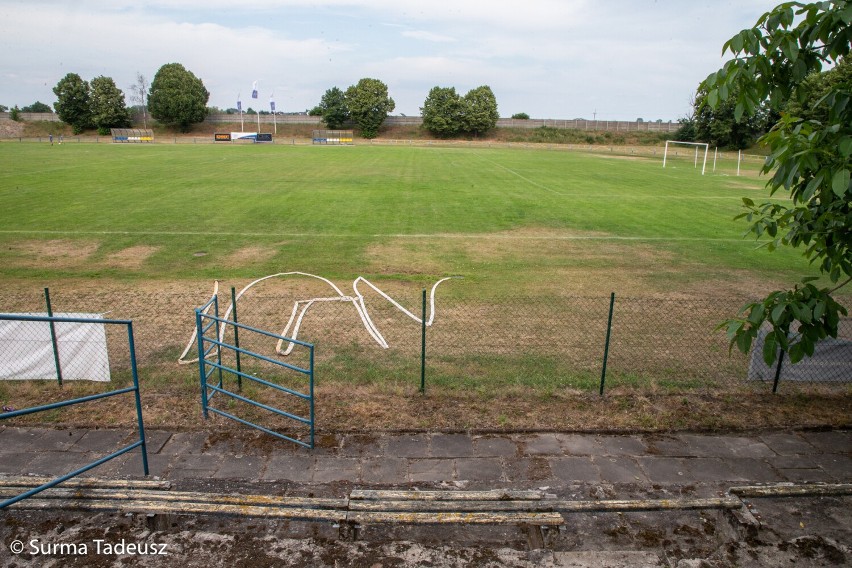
[0,0,779,121]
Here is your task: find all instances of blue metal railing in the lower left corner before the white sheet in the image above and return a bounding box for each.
[0,314,148,509]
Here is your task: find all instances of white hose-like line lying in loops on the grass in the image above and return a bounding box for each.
[178,272,455,365]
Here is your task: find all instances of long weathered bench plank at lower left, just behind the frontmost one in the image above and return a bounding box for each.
[0,487,349,509]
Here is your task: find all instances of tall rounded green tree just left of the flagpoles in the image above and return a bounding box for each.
[148,63,210,132]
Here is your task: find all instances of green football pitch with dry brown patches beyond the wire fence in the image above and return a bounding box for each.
[0,143,807,294]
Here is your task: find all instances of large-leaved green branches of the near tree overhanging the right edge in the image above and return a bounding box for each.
[702,0,852,365]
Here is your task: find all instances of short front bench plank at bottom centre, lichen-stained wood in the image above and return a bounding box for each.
[346,511,565,526]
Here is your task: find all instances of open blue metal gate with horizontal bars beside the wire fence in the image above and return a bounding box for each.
[195,296,315,449]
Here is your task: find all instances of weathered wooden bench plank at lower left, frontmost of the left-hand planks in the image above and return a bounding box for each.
[6,497,346,523]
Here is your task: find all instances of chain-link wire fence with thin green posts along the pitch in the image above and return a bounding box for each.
[0,285,852,394]
